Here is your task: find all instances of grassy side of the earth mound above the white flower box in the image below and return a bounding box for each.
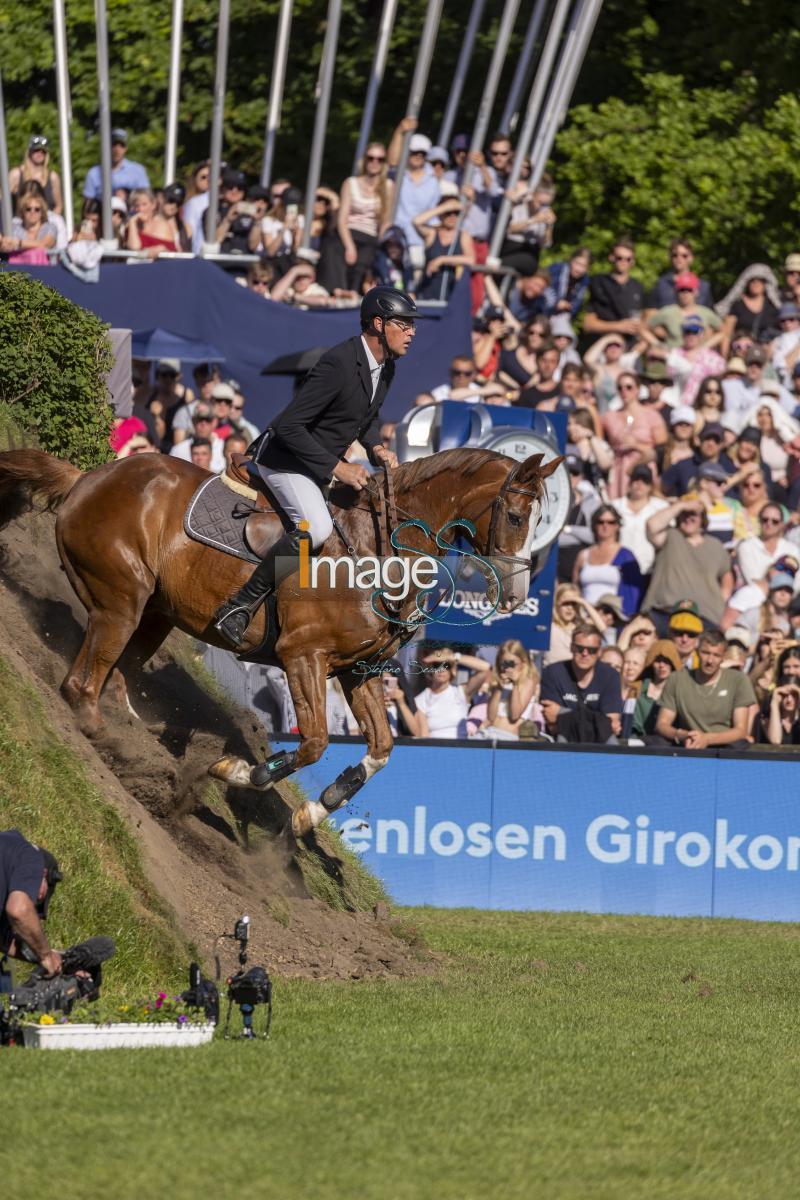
[0,656,188,989]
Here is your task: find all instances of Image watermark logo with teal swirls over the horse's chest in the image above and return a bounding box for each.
[299,517,503,626]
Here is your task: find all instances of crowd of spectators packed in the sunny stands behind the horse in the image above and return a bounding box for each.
[6,118,800,746]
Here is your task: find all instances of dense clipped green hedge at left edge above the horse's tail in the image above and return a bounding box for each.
[0,271,114,469]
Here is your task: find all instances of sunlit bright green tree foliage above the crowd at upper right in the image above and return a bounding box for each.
[555,74,800,283]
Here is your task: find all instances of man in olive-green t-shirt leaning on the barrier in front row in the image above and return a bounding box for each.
[656,630,757,750]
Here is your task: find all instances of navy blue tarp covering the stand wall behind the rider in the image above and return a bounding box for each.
[6,259,471,426]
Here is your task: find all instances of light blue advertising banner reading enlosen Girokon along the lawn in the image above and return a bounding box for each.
[282,742,800,920]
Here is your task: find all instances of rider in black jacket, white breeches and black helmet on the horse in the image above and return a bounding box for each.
[213,287,419,647]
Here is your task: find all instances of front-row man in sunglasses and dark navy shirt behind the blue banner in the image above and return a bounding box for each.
[540,624,622,742]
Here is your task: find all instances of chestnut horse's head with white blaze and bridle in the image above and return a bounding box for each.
[475,454,564,613]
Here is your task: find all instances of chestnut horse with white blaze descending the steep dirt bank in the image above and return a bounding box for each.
[0,449,561,835]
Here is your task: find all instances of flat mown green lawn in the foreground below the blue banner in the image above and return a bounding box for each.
[0,910,800,1200]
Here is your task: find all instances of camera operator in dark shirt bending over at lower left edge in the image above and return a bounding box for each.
[0,829,61,976]
